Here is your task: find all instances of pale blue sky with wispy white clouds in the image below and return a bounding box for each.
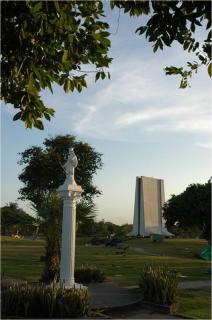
[1,3,212,224]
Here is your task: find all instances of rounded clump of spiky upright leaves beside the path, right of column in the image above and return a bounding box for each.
[139,265,179,305]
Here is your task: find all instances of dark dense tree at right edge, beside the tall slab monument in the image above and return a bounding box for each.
[163,179,211,241]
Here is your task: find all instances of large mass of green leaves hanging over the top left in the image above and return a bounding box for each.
[2,1,111,129]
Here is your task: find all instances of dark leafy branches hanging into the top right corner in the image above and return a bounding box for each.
[111,0,212,88]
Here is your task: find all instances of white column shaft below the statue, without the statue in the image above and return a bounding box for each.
[60,191,77,287]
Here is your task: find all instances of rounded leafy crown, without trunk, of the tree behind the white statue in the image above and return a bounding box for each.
[19,135,102,210]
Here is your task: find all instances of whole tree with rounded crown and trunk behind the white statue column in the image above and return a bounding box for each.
[19,135,102,282]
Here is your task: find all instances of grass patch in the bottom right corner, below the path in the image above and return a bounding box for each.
[176,287,211,319]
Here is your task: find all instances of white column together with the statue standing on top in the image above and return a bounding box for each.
[58,148,83,288]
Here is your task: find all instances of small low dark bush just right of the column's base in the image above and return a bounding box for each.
[74,267,105,283]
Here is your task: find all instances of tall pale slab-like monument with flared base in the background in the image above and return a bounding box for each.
[130,176,172,237]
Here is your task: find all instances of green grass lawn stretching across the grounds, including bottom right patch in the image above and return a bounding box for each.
[1,237,211,319]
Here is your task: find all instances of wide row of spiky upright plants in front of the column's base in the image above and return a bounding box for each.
[1,284,90,318]
